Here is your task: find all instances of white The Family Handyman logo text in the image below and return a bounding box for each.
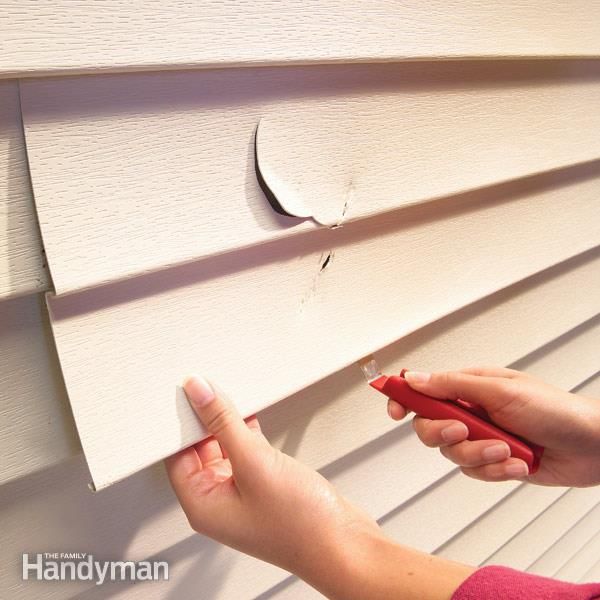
[23,552,169,585]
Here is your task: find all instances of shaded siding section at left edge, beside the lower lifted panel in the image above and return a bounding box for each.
[0,294,79,483]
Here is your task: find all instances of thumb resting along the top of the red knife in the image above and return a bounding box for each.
[404,371,514,412]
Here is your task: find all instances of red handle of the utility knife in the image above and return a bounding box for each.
[370,375,544,475]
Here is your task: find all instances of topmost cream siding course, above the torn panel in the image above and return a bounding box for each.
[0,0,600,75]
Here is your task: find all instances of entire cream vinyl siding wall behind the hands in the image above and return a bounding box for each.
[0,0,600,600]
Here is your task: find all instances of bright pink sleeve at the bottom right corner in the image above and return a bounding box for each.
[452,566,600,600]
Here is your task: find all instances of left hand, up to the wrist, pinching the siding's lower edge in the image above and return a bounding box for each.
[165,378,379,576]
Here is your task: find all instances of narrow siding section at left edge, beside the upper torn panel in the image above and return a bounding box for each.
[0,81,48,301]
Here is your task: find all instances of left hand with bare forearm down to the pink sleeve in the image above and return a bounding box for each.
[165,378,473,600]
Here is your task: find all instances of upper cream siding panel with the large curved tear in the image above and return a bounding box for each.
[21,61,600,294]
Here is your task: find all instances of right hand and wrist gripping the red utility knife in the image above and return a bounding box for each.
[388,368,600,486]
